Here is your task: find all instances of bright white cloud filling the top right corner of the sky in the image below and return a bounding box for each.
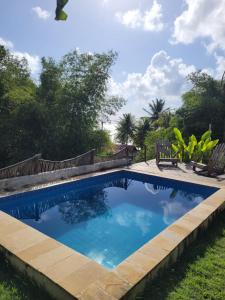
[173,0,225,52]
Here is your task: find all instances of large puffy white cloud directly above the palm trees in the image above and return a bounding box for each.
[109,50,196,116]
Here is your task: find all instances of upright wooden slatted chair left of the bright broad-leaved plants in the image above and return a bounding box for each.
[156,141,179,167]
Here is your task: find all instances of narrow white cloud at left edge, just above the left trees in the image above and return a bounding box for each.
[0,37,40,77]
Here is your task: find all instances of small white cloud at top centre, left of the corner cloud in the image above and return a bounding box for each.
[116,0,163,31]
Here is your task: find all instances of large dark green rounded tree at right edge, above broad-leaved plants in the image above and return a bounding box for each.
[176,71,225,141]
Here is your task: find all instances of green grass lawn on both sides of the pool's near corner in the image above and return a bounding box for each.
[0,213,225,300]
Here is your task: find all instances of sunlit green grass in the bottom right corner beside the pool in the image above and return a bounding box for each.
[140,212,225,300]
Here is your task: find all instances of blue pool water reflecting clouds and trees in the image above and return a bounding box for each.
[0,171,217,269]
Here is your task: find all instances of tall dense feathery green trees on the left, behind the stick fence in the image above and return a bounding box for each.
[0,46,124,167]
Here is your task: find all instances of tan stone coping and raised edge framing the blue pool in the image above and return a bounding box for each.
[0,168,225,300]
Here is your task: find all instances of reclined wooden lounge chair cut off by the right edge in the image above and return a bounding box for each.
[191,144,225,176]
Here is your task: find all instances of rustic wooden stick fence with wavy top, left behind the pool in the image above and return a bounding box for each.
[0,147,128,179]
